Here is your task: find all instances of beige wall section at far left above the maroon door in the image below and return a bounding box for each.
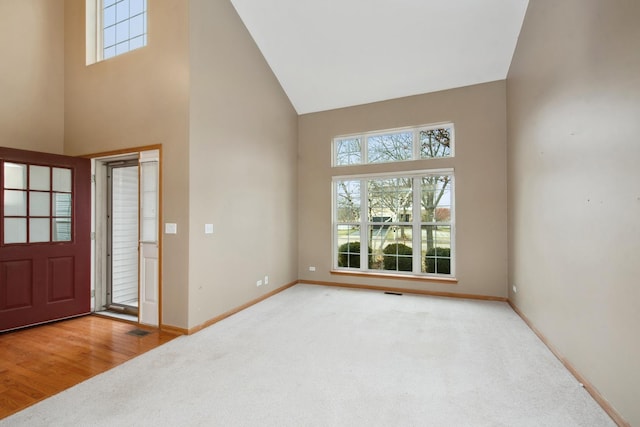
[0,0,64,154]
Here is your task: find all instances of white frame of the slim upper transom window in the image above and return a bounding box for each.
[331,122,455,167]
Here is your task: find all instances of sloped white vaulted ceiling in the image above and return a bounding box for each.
[231,0,528,114]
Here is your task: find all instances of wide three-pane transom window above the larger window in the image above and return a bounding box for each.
[333,123,454,166]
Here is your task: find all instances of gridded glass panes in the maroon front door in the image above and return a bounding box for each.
[2,162,73,244]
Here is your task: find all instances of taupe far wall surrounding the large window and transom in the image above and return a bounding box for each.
[298,81,507,297]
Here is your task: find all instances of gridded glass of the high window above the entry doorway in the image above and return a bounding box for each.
[101,0,147,59]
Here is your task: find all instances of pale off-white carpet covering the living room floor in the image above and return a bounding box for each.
[0,285,615,427]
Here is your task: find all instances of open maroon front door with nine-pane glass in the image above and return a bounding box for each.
[0,147,91,331]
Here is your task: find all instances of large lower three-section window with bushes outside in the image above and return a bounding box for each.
[333,169,455,277]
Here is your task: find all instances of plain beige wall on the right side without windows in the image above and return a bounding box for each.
[507,0,640,425]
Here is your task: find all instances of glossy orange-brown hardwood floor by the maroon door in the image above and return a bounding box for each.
[0,315,177,419]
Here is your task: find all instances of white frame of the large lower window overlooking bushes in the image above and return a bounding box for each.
[331,168,456,279]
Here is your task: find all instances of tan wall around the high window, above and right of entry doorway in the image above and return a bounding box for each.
[64,0,189,328]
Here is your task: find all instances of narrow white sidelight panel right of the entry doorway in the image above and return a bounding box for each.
[138,150,160,326]
